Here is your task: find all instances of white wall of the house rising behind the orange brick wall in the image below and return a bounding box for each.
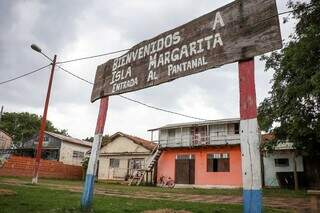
[59,141,91,166]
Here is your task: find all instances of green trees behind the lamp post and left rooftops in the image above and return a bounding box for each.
[0,112,68,146]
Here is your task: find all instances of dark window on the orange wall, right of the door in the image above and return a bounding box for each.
[207,153,230,172]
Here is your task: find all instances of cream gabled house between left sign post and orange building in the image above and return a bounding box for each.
[98,132,156,180]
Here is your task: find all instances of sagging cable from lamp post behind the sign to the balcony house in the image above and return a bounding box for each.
[58,66,207,121]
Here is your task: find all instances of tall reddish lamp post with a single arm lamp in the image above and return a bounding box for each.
[31,44,57,184]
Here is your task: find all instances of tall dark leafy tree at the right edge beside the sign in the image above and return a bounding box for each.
[258,0,320,190]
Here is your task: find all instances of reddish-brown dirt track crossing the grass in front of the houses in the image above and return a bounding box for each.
[1,179,310,213]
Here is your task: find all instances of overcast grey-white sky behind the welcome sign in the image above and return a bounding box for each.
[0,0,300,139]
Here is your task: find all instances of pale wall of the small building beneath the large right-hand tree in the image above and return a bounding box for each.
[263,152,303,187]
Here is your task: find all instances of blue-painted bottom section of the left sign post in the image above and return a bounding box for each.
[81,174,94,210]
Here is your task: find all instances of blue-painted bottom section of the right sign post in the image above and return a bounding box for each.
[243,189,262,213]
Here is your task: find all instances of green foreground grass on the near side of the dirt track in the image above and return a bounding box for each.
[0,184,290,213]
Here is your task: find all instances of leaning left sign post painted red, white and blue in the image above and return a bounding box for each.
[81,96,109,210]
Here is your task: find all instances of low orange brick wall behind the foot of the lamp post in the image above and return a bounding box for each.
[0,156,82,179]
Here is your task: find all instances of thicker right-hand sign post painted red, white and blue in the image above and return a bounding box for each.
[239,58,262,213]
